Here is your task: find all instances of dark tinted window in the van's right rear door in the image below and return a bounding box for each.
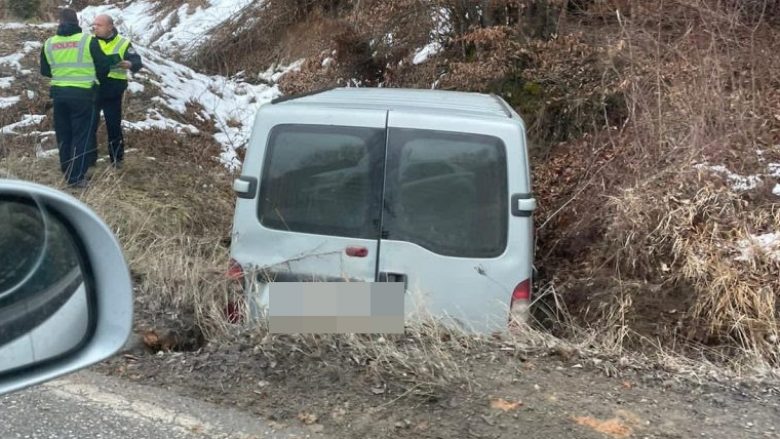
[383,128,509,258]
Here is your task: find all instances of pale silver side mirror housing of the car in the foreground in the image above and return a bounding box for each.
[0,179,133,395]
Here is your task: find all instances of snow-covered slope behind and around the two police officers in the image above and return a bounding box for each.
[0,0,301,169]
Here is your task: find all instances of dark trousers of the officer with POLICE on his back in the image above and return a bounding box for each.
[53,97,97,183]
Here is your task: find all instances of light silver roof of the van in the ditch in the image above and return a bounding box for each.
[272,87,513,119]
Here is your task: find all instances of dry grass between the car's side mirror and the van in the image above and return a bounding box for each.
[2,132,236,349]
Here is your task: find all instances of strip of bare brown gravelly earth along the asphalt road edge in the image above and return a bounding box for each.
[97,338,780,439]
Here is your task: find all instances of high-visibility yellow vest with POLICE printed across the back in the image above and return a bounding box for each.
[44,33,97,88]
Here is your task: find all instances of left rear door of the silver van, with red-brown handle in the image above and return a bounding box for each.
[232,104,387,306]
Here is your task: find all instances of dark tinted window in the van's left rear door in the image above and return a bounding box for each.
[258,124,385,239]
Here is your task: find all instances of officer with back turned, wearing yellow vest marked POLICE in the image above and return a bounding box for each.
[40,8,111,187]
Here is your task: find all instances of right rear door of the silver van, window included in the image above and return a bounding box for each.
[378,111,533,332]
